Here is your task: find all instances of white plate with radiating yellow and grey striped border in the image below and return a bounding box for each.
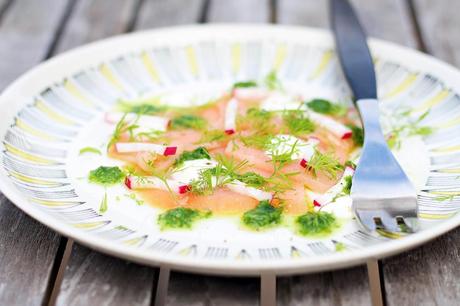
[0,25,460,275]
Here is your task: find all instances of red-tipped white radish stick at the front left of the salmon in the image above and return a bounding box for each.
[125,176,190,194]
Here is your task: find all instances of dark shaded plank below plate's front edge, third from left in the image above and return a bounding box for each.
[166,273,260,306]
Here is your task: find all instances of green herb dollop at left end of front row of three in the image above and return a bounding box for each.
[157,207,211,230]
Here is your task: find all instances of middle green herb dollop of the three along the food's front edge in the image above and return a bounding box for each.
[241,200,282,230]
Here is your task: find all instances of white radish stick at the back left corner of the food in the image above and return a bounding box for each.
[104,112,169,131]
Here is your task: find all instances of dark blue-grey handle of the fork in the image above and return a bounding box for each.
[330,0,377,101]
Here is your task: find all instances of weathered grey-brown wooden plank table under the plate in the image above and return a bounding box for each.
[0,0,460,305]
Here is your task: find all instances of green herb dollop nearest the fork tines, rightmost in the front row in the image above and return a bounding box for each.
[295,211,338,235]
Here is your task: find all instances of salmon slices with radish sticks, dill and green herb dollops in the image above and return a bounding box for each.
[90,73,362,235]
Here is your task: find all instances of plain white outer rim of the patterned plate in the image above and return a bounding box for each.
[0,24,460,276]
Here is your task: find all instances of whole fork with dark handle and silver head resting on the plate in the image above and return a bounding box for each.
[330,0,418,233]
